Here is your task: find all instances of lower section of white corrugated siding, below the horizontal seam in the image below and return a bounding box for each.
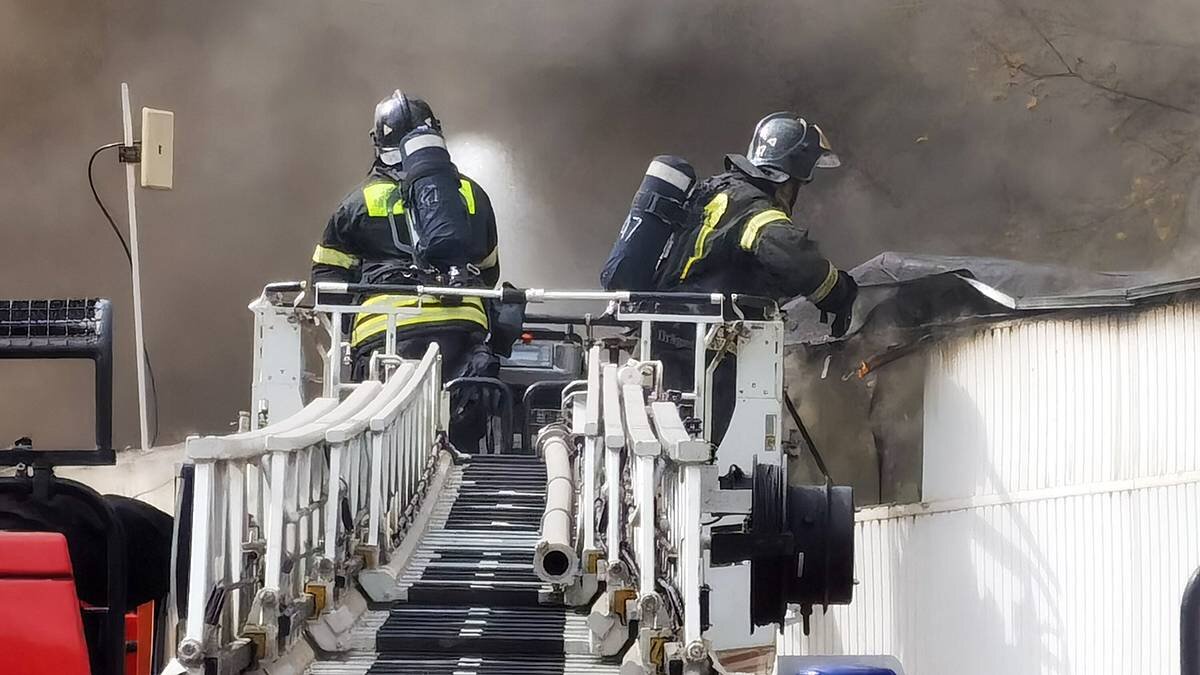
[781,483,1200,675]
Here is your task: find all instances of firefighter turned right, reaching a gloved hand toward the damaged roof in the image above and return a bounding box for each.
[653,112,858,443]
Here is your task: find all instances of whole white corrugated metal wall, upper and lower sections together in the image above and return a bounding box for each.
[781,304,1200,675]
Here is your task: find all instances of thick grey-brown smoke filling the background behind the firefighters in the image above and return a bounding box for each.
[0,0,1200,443]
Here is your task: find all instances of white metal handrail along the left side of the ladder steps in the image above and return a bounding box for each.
[178,345,443,673]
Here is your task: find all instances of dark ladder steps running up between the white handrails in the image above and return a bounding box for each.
[310,455,619,675]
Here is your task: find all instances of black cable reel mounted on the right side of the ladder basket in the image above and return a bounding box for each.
[710,464,854,634]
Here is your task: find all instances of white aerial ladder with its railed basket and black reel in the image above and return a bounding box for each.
[0,282,853,675]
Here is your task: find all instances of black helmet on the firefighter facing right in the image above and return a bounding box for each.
[746,113,841,183]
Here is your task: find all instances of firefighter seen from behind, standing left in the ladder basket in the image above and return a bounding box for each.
[312,90,500,452]
